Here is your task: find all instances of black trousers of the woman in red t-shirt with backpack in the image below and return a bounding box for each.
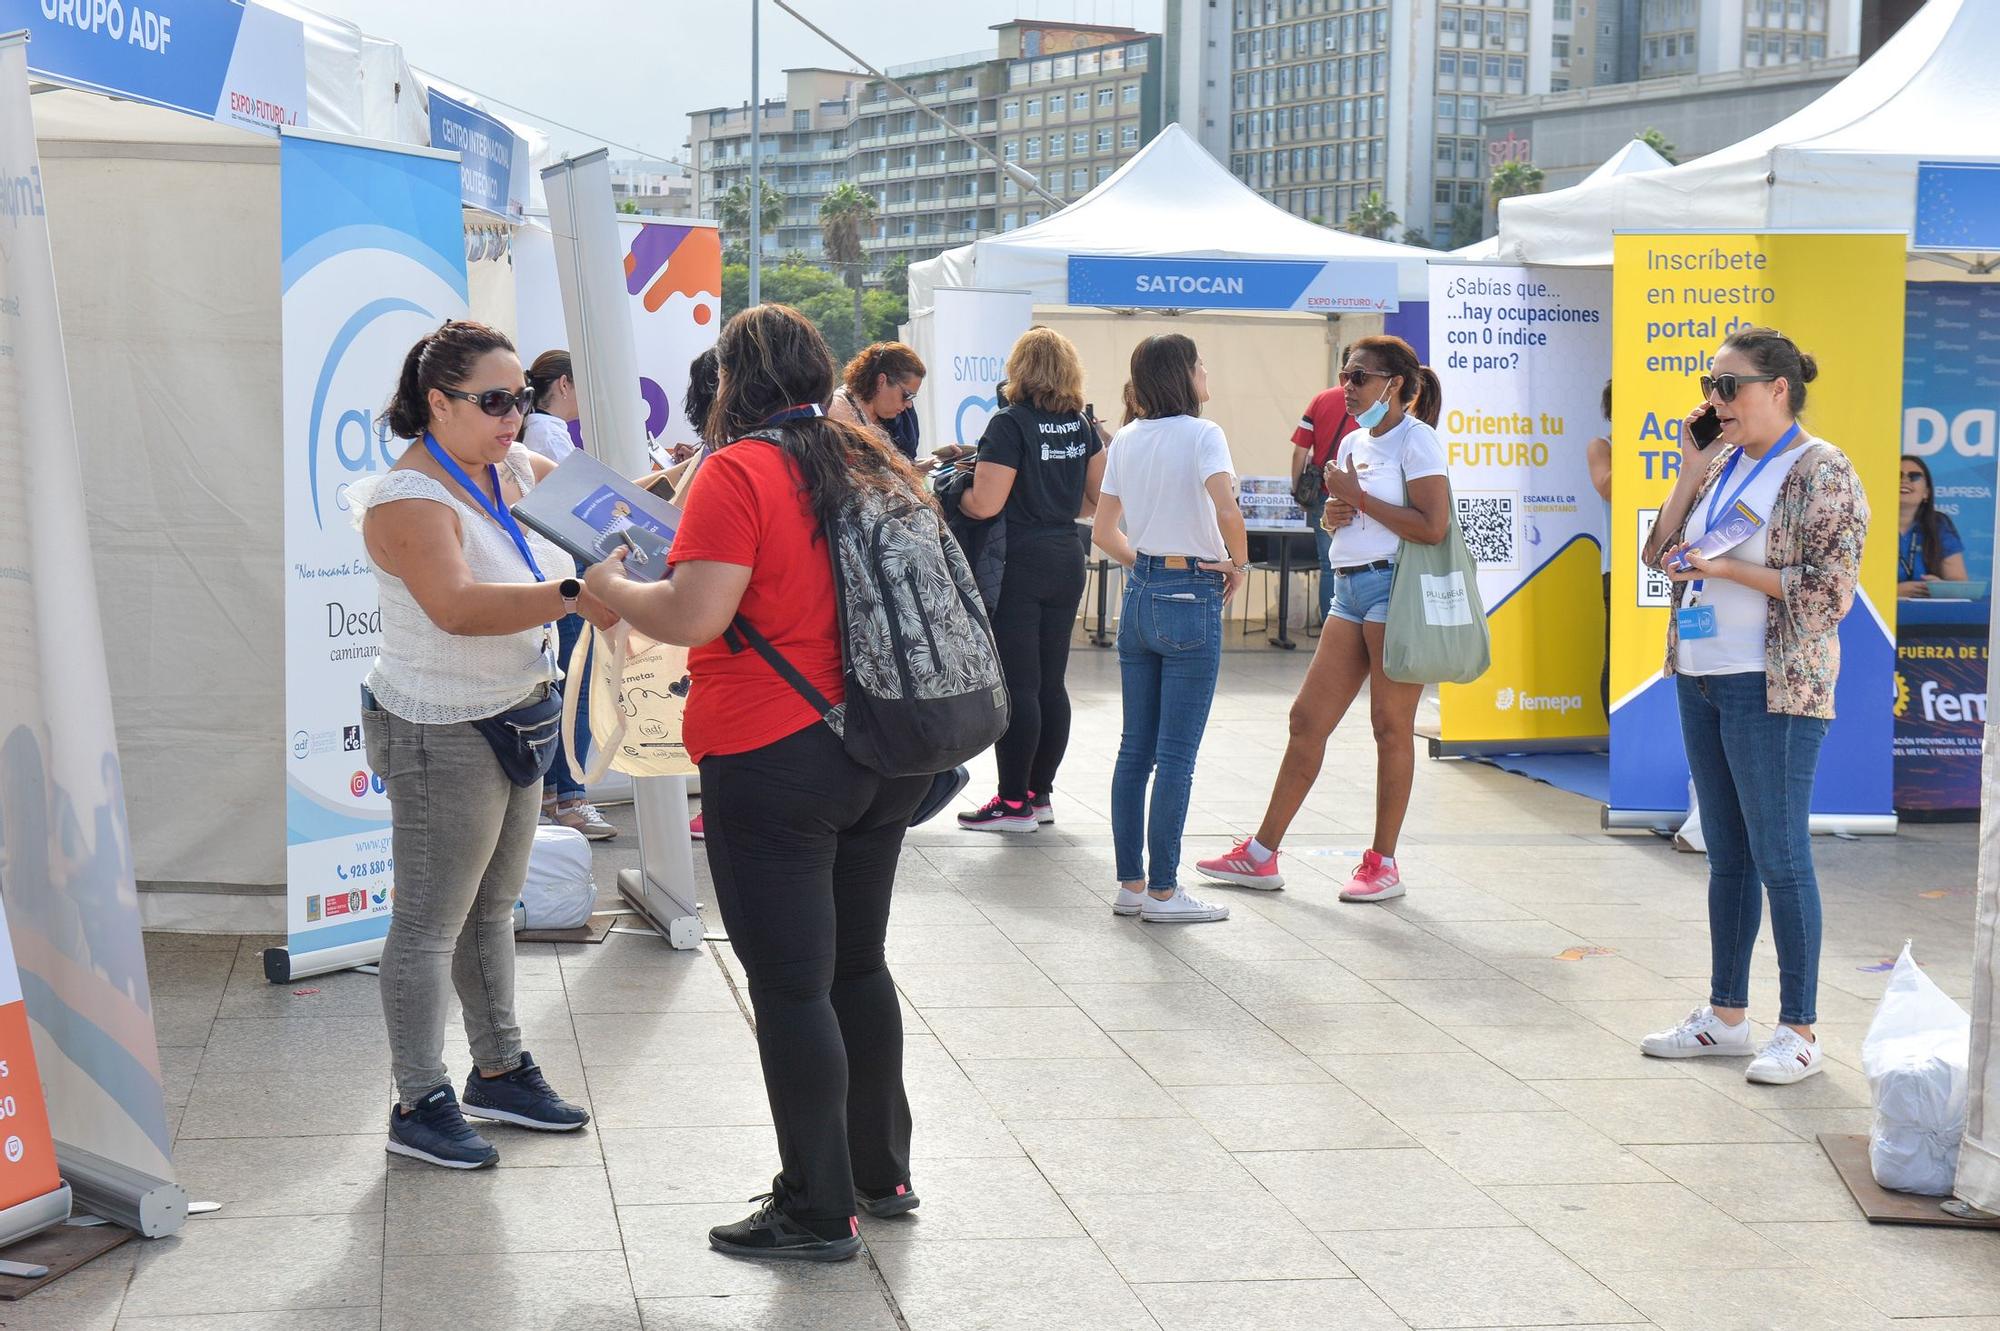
[702,723,930,1223]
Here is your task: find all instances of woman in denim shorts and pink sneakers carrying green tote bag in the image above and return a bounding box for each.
[1198,336,1452,901]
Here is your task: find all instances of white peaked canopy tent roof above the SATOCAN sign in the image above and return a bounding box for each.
[910,124,1436,314]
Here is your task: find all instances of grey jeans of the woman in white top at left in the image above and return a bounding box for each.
[362,709,542,1105]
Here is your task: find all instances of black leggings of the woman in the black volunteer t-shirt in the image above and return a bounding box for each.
[994,528,1084,801]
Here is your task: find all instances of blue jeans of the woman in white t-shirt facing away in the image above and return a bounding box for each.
[1112,556,1222,891]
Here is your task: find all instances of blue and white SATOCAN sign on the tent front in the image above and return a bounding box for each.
[1070,254,1396,314]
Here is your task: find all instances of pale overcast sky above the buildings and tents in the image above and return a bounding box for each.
[304,0,1162,158]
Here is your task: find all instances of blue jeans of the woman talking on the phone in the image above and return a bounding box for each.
[1676,671,1826,1025]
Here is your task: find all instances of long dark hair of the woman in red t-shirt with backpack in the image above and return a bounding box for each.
[702,304,932,536]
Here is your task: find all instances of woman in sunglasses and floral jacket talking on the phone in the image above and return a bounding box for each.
[1640,328,1868,1085]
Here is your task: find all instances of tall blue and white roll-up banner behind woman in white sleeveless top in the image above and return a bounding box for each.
[264,132,466,983]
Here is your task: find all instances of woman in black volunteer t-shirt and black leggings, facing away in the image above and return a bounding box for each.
[958,328,1104,831]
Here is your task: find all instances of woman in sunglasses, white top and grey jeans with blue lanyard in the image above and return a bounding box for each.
[348,322,616,1169]
